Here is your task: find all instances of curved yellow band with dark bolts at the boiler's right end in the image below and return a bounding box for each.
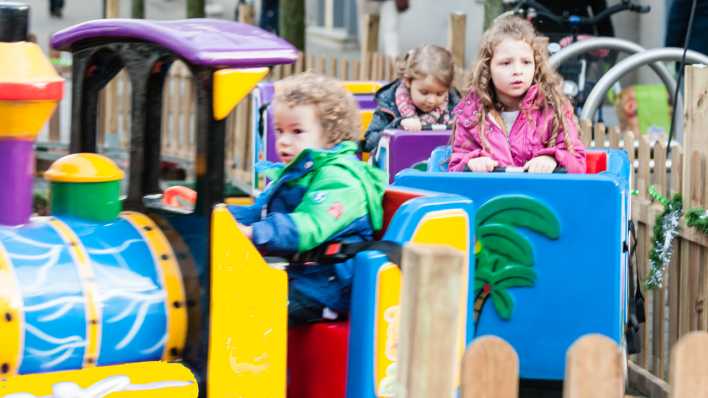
[121,211,187,361]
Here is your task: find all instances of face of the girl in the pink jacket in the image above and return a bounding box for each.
[490,39,536,102]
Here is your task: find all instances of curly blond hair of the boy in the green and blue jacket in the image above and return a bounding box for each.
[273,72,359,145]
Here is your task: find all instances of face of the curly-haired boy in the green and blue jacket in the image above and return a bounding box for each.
[273,102,328,163]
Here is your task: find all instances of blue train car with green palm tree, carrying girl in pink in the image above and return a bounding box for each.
[394,150,630,380]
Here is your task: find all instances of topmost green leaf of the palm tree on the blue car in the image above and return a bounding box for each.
[475,195,560,239]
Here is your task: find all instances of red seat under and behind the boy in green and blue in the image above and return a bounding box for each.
[288,188,422,398]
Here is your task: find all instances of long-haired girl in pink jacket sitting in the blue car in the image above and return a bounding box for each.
[448,17,585,173]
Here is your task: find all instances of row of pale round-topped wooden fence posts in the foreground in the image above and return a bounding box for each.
[393,245,708,398]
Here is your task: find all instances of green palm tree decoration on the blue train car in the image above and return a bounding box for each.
[474,195,560,332]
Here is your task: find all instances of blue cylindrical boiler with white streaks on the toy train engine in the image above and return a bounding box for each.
[0,213,183,374]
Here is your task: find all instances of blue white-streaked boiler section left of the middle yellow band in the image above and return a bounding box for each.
[0,223,87,374]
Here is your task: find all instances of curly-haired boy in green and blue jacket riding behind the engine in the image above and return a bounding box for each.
[229,73,386,326]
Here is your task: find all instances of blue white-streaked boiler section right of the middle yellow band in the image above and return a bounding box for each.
[63,218,167,365]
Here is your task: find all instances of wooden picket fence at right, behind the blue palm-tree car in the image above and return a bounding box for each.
[582,123,708,386]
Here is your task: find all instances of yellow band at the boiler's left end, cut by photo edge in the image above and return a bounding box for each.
[0,243,24,380]
